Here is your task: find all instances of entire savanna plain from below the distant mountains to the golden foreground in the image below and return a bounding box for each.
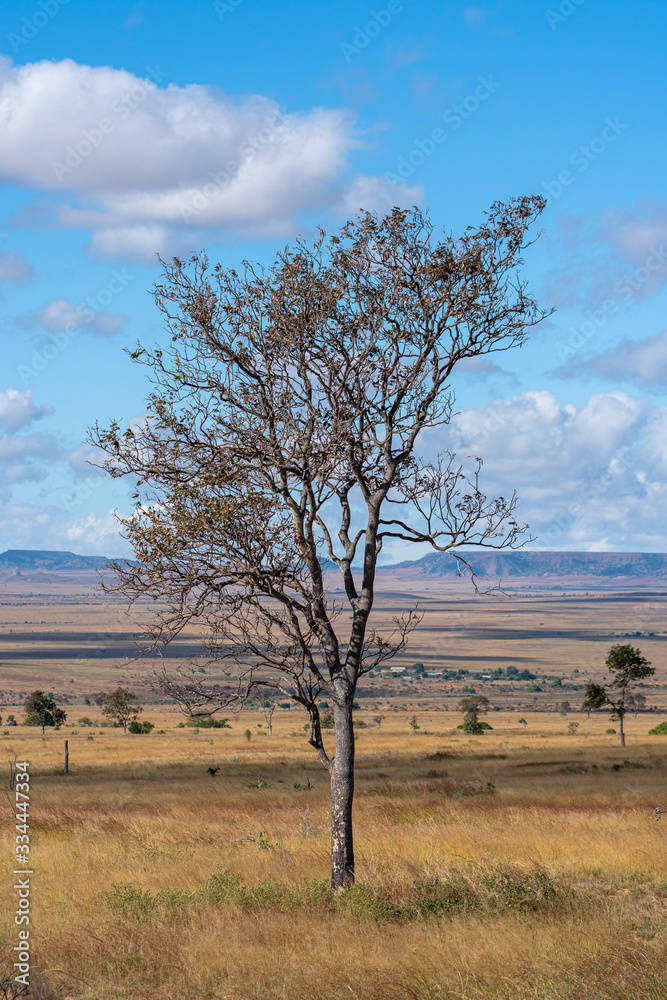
[0,575,667,1000]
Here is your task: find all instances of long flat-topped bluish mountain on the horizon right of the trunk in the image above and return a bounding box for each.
[382,551,667,579]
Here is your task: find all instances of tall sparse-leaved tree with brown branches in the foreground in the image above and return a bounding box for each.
[90,197,546,890]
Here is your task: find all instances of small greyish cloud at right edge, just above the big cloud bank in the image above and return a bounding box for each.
[554,330,667,389]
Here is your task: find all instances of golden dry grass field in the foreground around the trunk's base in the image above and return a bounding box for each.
[0,708,667,1000]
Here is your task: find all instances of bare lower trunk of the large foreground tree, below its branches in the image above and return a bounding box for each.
[331,695,354,892]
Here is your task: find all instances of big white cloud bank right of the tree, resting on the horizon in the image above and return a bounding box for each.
[428,391,667,551]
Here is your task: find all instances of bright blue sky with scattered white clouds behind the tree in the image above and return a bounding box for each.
[0,0,667,560]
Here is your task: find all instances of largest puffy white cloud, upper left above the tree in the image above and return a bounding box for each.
[0,59,421,260]
